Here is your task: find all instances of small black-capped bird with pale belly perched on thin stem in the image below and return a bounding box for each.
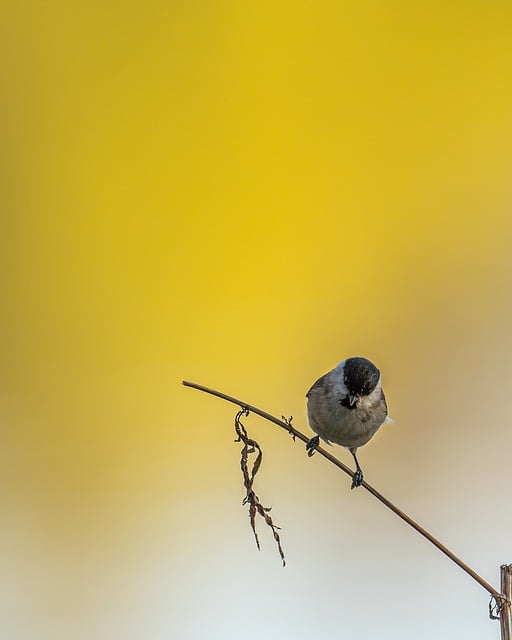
[306,357,391,489]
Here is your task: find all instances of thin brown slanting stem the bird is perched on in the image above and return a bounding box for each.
[183,380,504,610]
